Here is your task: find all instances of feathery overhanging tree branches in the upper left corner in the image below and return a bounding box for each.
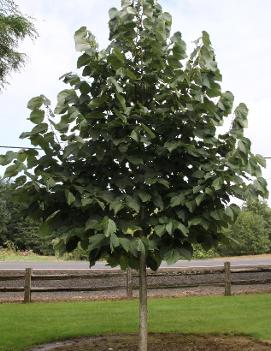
[0,0,37,90]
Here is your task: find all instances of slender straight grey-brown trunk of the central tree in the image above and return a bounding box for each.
[139,252,148,351]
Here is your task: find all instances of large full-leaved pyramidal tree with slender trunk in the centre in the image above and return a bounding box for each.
[1,0,267,351]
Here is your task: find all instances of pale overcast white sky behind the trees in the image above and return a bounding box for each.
[0,0,271,203]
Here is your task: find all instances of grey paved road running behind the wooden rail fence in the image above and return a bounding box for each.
[0,255,271,270]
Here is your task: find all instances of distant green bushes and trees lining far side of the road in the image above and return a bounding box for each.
[0,182,271,260]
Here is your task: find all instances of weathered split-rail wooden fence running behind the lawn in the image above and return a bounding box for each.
[0,262,271,303]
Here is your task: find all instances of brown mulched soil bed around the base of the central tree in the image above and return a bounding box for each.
[32,334,271,351]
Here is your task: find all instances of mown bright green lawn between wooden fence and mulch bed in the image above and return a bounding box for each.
[0,294,271,351]
